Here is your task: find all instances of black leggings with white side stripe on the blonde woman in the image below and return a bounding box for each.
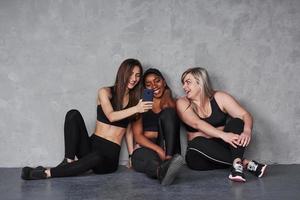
[185,118,245,170]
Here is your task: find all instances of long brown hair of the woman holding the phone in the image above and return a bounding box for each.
[112,58,143,110]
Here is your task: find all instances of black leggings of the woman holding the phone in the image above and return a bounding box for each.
[50,110,121,177]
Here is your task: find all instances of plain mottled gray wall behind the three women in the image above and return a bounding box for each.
[0,0,300,167]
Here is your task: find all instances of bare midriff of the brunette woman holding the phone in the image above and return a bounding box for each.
[95,120,126,145]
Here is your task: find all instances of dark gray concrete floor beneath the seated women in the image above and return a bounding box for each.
[0,165,300,200]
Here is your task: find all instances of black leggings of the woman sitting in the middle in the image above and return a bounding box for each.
[131,108,181,178]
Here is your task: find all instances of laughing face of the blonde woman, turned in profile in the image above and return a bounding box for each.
[182,73,201,100]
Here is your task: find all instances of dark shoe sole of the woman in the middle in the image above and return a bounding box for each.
[161,156,184,186]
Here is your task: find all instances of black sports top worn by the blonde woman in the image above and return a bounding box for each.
[184,97,228,132]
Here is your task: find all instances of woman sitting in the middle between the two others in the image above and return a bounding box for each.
[132,68,183,185]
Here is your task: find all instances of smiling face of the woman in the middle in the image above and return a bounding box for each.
[144,74,166,98]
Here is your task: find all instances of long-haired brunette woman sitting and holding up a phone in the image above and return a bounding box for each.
[21,59,152,180]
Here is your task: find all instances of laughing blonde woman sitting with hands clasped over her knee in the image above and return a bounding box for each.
[176,68,267,182]
